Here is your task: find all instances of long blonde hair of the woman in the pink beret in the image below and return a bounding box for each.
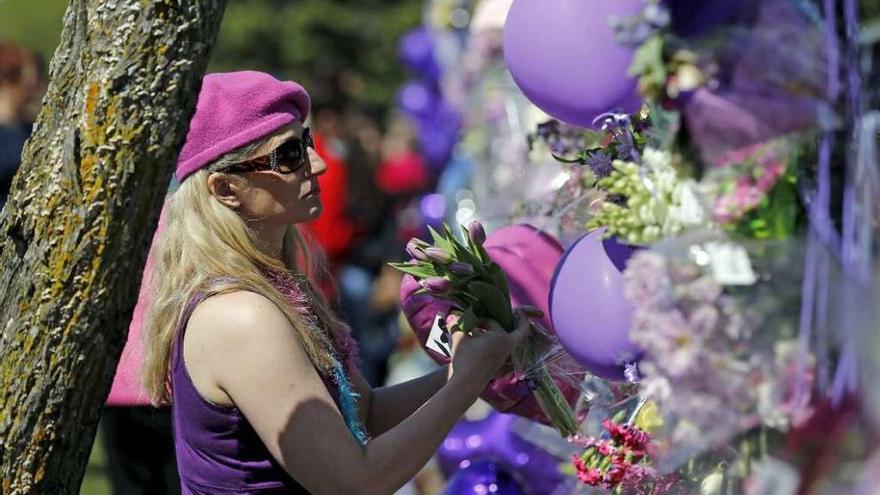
[142,138,347,404]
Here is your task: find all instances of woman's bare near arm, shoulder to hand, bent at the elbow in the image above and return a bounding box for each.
[185,292,528,495]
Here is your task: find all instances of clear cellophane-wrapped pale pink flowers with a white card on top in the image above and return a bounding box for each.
[624,233,815,467]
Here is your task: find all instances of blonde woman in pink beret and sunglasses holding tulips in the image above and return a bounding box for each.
[143,71,529,495]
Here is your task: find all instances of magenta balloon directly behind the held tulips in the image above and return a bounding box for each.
[400,225,583,422]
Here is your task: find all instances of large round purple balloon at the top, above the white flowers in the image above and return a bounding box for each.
[504,0,645,127]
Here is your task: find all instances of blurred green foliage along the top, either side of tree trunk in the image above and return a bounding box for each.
[0,0,424,114]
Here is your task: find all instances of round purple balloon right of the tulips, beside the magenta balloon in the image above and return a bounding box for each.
[550,229,641,381]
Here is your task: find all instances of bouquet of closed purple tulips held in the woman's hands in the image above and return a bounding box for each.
[392,221,578,437]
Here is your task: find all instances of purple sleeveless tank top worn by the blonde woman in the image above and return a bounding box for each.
[171,280,357,495]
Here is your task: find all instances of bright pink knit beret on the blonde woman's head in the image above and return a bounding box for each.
[175,71,309,181]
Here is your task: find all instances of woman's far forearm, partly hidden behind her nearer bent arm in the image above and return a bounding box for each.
[352,366,449,436]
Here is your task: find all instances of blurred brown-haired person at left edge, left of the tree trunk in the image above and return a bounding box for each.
[0,41,45,208]
